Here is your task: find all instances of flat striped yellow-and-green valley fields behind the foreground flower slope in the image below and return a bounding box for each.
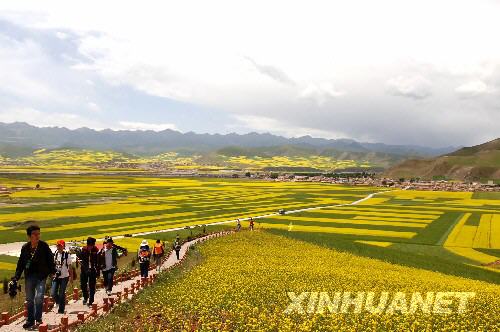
[0,175,500,281]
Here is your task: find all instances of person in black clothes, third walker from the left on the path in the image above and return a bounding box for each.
[77,237,100,307]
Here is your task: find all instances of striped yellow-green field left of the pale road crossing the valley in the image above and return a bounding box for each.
[0,175,377,270]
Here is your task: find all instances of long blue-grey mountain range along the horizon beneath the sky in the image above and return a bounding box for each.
[0,122,457,159]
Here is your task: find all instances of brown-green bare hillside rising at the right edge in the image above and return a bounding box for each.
[385,138,500,181]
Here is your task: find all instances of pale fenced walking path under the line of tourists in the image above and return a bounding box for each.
[0,232,230,332]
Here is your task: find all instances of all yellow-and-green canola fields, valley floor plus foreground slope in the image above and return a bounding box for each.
[0,174,500,331]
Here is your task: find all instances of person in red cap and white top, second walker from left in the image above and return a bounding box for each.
[50,240,73,314]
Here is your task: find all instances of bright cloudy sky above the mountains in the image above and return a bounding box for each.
[0,0,500,147]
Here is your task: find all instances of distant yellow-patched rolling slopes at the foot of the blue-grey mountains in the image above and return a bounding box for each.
[0,149,375,173]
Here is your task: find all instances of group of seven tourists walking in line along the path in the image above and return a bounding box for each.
[9,225,181,329]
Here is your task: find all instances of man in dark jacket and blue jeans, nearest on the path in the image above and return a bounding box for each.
[12,225,56,329]
